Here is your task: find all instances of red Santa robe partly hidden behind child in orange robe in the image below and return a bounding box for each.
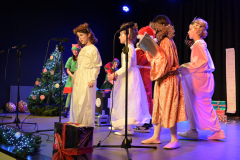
[136,48,153,116]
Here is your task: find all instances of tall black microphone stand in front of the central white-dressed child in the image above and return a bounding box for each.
[93,29,157,160]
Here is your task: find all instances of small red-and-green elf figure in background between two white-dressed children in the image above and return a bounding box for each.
[100,58,119,89]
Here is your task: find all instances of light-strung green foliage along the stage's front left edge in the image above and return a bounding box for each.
[0,125,42,157]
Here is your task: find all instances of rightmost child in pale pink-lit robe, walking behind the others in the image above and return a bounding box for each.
[178,18,226,139]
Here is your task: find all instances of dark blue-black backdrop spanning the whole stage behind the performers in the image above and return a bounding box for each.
[0,0,240,116]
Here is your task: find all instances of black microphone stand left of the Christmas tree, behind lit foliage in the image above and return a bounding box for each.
[0,48,37,129]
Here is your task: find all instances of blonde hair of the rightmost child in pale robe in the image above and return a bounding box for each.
[191,18,208,38]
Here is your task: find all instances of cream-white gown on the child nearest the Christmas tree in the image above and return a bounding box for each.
[70,45,102,127]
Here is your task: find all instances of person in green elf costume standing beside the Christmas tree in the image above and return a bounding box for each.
[62,44,80,118]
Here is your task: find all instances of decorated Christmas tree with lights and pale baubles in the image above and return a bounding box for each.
[28,46,67,116]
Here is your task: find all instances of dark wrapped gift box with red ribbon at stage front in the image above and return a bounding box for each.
[52,122,94,160]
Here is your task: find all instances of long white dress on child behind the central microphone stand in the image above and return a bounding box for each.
[110,44,151,127]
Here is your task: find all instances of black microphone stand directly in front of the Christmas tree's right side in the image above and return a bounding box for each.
[33,41,64,133]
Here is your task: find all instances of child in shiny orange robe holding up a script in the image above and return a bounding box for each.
[142,15,187,149]
